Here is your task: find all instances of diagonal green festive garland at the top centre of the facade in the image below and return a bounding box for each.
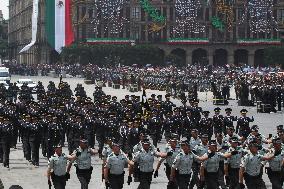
[140,0,166,23]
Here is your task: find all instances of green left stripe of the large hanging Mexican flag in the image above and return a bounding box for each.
[45,0,55,47]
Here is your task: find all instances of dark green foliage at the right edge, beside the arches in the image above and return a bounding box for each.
[264,47,284,69]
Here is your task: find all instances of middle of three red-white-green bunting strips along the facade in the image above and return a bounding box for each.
[166,38,209,45]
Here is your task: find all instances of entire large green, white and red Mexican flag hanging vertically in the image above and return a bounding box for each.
[46,0,74,53]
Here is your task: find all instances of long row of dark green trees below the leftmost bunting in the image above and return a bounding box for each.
[61,44,164,65]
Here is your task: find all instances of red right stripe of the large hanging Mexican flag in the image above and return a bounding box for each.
[65,0,74,46]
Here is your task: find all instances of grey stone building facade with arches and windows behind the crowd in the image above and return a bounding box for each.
[9,0,284,66]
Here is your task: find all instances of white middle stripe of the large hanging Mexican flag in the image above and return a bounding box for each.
[54,0,65,52]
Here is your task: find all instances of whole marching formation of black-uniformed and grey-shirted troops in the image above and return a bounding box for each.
[0,75,284,189]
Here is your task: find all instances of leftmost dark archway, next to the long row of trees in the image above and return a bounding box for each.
[169,48,186,66]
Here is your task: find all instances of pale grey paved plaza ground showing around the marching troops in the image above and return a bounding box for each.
[0,76,284,189]
